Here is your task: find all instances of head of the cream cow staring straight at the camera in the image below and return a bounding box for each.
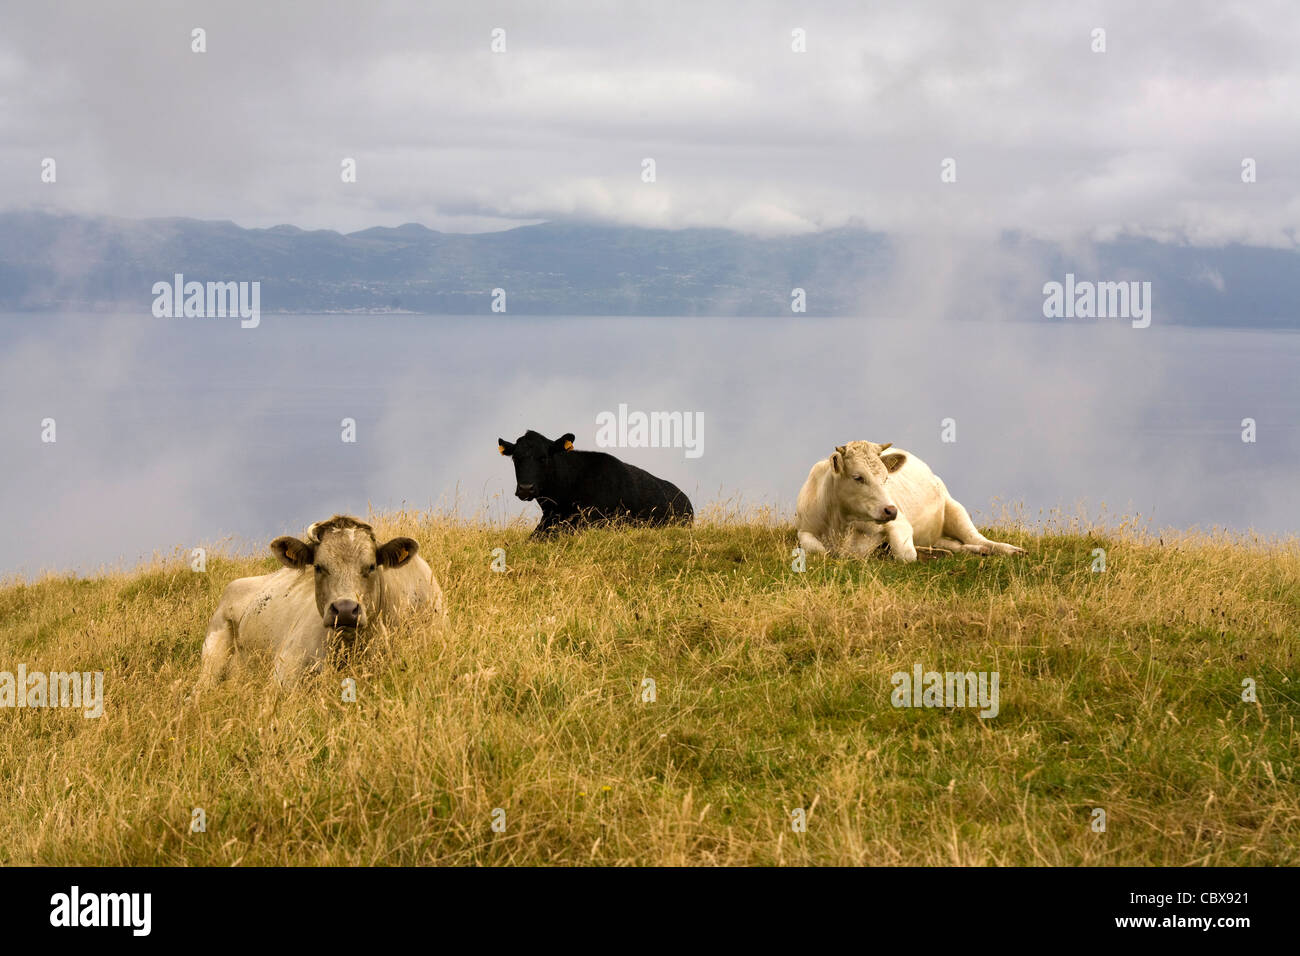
[270,515,420,627]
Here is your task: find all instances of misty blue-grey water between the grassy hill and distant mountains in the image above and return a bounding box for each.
[0,313,1300,576]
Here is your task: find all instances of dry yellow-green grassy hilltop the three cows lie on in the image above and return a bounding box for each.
[0,514,1300,865]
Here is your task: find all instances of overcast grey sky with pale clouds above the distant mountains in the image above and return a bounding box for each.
[0,0,1300,247]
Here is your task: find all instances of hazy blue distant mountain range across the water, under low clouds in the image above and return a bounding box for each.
[0,211,1300,328]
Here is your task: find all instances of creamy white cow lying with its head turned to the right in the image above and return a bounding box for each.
[796,441,1024,562]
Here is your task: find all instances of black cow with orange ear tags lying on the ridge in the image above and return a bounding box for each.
[497,431,694,537]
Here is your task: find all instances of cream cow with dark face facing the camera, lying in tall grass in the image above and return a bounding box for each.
[199,515,445,688]
